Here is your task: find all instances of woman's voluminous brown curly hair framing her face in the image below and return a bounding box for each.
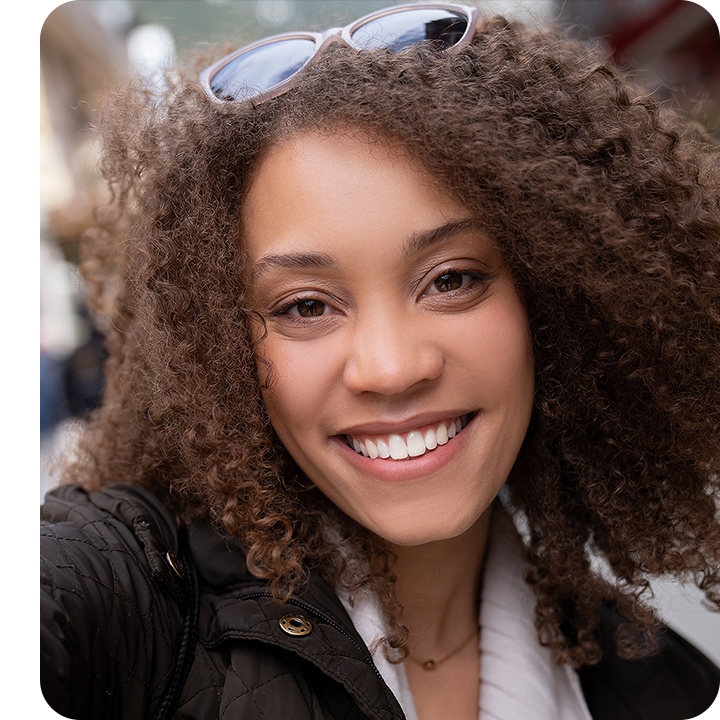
[67,11,720,666]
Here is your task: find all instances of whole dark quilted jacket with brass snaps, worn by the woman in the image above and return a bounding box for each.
[41,485,720,720]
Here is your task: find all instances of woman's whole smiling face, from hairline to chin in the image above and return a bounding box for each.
[243,133,534,545]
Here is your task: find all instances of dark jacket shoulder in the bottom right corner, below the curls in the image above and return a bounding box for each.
[578,606,720,720]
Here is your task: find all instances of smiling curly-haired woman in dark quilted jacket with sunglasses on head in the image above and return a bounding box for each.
[42,5,720,720]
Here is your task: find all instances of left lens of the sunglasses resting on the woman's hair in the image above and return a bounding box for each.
[210,38,315,101]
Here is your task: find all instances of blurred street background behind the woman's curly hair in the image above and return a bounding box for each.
[39,0,720,664]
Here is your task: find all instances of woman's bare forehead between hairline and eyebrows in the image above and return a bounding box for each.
[243,132,470,261]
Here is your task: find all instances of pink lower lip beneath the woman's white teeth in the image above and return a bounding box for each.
[332,415,478,482]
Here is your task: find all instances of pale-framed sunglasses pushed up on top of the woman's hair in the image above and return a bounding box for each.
[200,3,480,103]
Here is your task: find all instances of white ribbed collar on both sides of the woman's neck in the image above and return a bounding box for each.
[338,507,592,720]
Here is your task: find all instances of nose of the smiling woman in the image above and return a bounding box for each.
[343,315,445,395]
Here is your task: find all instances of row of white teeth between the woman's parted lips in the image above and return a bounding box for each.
[345,413,473,460]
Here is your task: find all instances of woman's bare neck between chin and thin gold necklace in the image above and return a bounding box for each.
[393,509,490,658]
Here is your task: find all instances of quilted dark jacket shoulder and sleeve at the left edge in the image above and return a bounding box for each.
[40,485,184,718]
